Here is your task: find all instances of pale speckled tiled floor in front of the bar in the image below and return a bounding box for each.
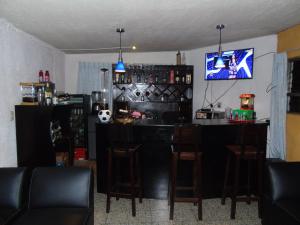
[95,193,261,225]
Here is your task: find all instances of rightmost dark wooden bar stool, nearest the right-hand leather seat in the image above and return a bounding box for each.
[221,124,266,219]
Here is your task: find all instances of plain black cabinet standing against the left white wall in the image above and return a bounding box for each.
[15,105,71,167]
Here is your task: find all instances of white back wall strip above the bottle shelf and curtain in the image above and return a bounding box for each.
[65,52,177,93]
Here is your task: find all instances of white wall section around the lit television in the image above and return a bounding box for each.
[187,35,277,119]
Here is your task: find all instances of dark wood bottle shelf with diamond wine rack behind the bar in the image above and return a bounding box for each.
[113,64,193,121]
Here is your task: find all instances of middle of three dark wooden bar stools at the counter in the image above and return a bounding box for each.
[169,125,202,220]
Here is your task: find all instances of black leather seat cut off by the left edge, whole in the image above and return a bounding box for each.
[0,168,25,225]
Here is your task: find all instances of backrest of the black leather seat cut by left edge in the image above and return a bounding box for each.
[0,168,25,210]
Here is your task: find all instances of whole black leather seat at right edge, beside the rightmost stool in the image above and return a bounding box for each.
[262,162,300,225]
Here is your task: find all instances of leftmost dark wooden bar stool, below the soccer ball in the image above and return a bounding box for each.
[106,125,142,216]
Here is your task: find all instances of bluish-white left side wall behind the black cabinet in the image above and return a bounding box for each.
[0,18,65,167]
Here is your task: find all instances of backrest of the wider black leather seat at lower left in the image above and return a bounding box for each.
[29,167,92,208]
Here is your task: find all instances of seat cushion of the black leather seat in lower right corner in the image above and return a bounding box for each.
[275,199,300,224]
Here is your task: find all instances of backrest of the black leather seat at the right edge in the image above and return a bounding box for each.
[268,162,300,201]
